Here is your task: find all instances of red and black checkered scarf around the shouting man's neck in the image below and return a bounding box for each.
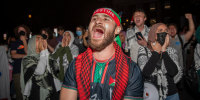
[75,42,129,100]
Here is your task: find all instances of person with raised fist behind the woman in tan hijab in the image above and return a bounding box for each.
[168,13,195,98]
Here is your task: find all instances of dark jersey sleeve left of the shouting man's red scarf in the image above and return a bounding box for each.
[62,59,77,90]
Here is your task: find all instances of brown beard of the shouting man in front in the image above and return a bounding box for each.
[88,31,115,51]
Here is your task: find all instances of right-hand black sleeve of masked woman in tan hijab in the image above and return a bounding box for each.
[162,52,178,77]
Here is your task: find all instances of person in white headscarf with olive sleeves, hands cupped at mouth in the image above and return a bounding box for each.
[52,31,79,82]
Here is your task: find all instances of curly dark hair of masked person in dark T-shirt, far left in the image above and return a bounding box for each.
[14,24,30,38]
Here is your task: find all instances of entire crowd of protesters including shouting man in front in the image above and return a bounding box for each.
[0,8,200,100]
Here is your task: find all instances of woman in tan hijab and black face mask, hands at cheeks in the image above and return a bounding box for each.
[138,23,182,100]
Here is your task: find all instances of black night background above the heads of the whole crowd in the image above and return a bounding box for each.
[0,0,200,35]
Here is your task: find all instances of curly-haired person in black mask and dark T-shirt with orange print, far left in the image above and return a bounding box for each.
[11,25,30,100]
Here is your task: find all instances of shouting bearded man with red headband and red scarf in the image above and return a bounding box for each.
[60,8,143,100]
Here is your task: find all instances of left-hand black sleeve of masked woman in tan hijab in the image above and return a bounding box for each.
[143,51,160,79]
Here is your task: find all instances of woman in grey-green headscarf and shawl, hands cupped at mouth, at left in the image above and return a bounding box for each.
[20,35,61,100]
